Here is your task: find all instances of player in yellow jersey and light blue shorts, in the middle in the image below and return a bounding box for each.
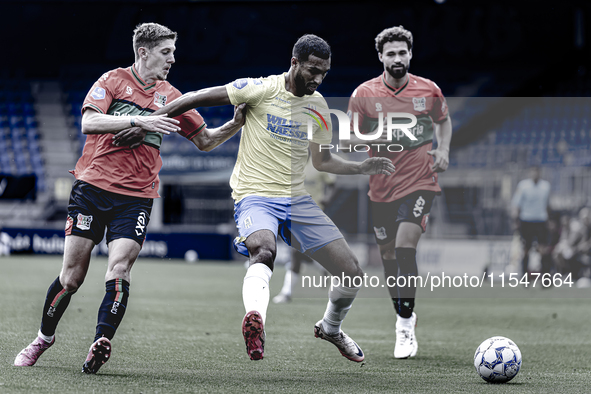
[147,34,394,362]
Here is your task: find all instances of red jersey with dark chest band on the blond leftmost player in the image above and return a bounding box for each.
[71,66,205,198]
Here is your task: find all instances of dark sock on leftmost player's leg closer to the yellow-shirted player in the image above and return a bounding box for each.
[94,279,129,341]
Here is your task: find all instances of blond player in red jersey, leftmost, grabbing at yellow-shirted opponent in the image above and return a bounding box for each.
[14,23,244,373]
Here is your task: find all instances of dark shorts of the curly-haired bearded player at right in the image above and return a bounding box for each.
[370,190,436,245]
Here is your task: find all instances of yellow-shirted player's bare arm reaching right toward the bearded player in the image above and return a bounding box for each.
[310,142,396,175]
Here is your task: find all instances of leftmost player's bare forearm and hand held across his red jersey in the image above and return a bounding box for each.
[81,108,179,134]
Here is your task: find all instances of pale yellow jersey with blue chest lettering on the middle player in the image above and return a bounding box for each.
[226,74,332,201]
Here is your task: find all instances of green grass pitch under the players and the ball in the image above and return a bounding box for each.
[0,256,591,394]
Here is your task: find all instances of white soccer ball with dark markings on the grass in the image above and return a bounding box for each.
[474,337,521,383]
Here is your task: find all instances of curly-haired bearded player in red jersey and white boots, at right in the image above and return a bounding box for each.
[349,26,452,358]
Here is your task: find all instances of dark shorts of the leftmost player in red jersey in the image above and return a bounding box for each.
[66,180,154,246]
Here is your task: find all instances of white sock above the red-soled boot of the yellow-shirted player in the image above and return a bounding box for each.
[242,263,273,324]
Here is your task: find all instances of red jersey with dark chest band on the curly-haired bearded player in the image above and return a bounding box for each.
[349,74,448,202]
